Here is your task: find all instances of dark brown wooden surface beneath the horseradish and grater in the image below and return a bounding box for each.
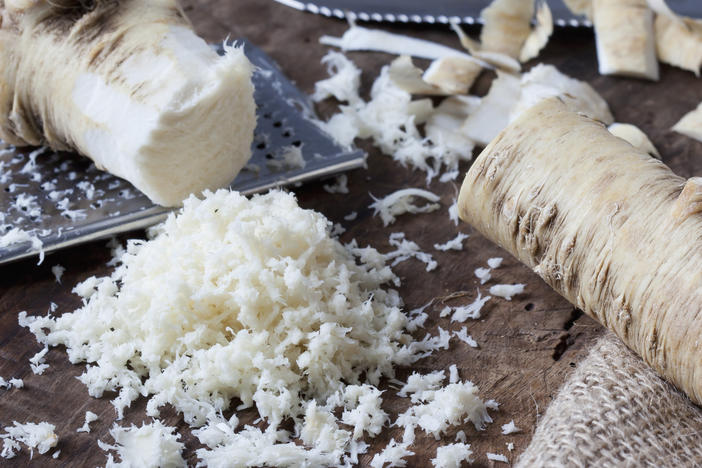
[0,0,702,466]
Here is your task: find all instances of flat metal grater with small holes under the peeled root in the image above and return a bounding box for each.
[0,41,365,263]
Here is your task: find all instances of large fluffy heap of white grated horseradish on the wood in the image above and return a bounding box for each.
[20,190,440,466]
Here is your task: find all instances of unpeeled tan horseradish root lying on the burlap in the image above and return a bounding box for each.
[458,99,702,404]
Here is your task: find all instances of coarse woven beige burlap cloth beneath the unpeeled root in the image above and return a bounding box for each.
[516,334,702,467]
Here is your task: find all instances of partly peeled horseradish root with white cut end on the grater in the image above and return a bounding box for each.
[0,0,256,205]
